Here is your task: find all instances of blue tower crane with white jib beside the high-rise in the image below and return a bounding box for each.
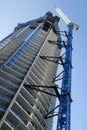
[55,6,79,130]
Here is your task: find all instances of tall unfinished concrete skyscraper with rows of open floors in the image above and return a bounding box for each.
[0,12,60,130]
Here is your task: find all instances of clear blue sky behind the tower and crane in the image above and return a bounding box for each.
[0,0,87,130]
